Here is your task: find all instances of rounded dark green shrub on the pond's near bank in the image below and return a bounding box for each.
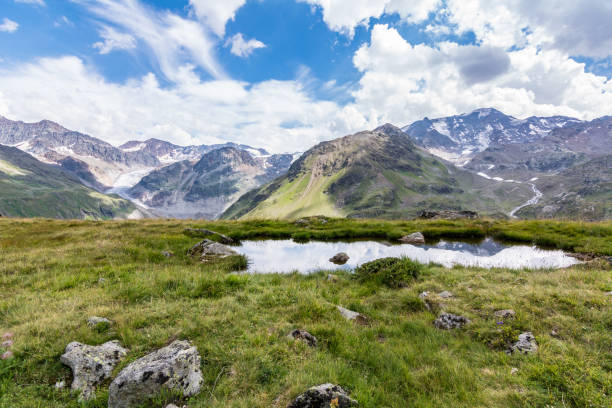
[355,257,424,288]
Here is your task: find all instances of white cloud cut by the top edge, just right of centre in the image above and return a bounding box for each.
[300,0,442,37]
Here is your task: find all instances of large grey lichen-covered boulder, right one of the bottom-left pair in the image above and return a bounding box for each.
[108,340,203,408]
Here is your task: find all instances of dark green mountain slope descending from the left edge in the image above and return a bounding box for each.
[0,145,136,219]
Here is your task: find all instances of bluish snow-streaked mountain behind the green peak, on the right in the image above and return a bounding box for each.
[402,108,581,165]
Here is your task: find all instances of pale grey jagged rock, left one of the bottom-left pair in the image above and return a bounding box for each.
[60,340,128,400]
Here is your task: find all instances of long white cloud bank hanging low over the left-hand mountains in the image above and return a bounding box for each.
[0,57,371,152]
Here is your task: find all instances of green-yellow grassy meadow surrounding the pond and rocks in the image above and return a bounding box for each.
[0,220,612,408]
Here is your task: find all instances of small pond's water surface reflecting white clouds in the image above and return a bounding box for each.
[236,240,578,273]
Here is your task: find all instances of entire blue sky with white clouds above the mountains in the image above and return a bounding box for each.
[0,0,612,152]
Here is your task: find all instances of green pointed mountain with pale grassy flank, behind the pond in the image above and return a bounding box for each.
[223,125,533,219]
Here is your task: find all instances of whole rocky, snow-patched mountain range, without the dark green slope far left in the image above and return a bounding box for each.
[0,108,612,220]
